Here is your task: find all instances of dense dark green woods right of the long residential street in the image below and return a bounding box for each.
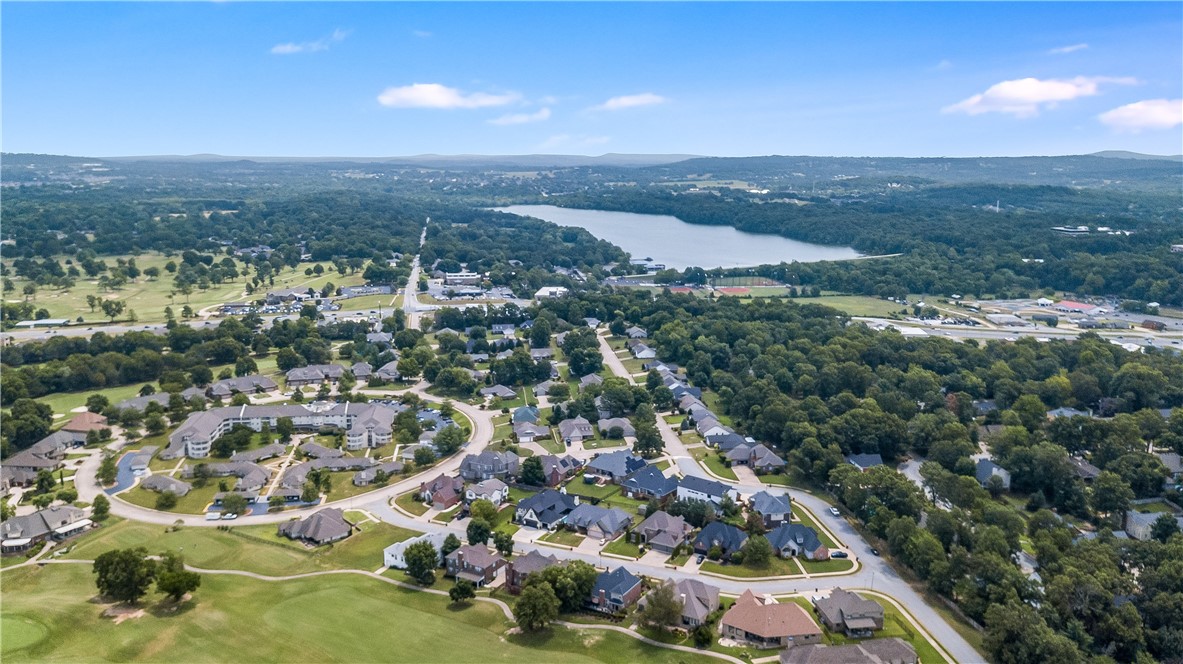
[542,292,1183,663]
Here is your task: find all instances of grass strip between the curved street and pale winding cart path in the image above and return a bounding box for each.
[62,512,419,575]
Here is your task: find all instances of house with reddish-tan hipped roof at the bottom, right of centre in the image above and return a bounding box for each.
[719,591,821,647]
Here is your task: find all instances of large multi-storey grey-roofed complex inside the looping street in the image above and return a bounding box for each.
[160,402,397,459]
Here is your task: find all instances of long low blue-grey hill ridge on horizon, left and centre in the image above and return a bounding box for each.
[103,153,697,168]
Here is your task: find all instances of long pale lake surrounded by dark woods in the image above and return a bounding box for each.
[496,205,860,270]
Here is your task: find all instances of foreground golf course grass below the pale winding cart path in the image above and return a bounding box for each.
[0,565,706,664]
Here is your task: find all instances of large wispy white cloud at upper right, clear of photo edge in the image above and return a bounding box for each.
[942,76,1138,117]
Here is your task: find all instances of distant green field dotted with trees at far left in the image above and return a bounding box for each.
[5,253,362,324]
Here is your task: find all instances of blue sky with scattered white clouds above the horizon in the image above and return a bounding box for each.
[0,2,1183,156]
